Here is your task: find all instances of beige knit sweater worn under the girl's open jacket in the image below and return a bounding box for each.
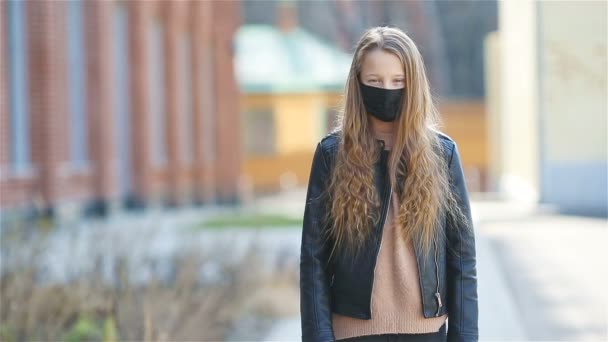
[332,127,447,339]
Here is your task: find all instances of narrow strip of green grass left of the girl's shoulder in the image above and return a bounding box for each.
[196,213,302,229]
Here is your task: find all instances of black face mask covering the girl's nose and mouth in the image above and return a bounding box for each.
[359,81,403,122]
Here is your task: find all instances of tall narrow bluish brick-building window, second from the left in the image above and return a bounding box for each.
[67,0,88,166]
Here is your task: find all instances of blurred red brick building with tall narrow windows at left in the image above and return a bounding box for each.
[0,1,241,218]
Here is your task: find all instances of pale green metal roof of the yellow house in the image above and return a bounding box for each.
[234,25,352,93]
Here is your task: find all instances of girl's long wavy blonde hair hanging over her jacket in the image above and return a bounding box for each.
[325,26,465,268]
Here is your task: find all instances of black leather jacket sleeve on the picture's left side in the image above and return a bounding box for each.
[300,143,335,341]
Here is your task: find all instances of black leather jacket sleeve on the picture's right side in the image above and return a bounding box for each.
[447,143,479,342]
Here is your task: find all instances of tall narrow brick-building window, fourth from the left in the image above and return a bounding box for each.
[148,21,167,166]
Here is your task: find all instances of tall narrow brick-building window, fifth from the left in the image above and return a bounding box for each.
[176,34,194,164]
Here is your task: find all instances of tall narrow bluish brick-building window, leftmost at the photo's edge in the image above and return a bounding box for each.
[6,1,31,172]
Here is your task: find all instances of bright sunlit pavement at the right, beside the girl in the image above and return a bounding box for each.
[481,214,608,341]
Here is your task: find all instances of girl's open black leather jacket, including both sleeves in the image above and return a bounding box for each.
[300,132,479,341]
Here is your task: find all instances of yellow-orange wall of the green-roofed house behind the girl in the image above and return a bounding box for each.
[242,93,488,192]
